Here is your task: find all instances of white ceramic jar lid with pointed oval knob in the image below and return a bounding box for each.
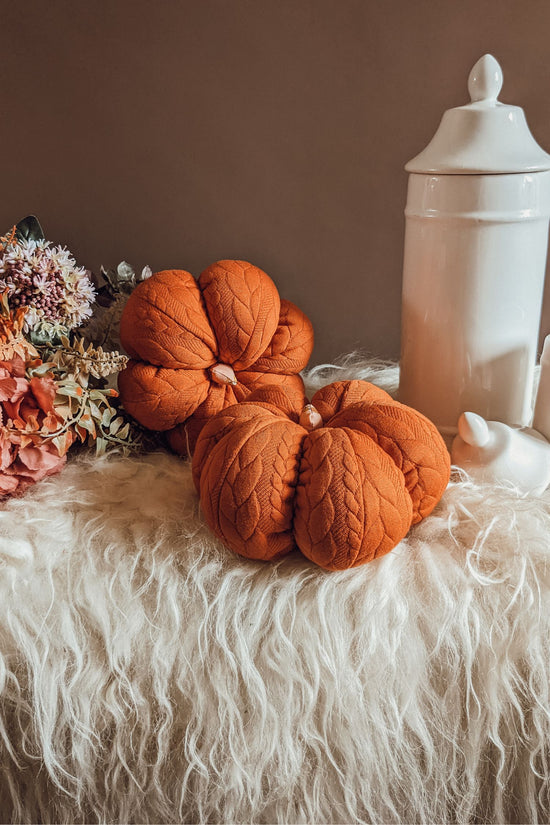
[405,54,550,175]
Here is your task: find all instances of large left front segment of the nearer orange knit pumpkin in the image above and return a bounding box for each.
[200,408,305,560]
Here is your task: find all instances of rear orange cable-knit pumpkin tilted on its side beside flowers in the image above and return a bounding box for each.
[119,261,313,455]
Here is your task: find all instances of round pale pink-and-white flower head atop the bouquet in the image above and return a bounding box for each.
[0,241,95,332]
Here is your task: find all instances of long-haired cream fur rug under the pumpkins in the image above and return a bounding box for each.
[0,356,550,823]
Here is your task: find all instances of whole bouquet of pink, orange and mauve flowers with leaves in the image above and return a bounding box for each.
[0,216,151,497]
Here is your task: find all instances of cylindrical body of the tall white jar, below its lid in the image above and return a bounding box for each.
[399,172,550,434]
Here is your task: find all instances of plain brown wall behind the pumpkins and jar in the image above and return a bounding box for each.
[0,0,550,362]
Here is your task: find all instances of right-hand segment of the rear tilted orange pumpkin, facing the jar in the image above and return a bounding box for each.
[251,298,313,373]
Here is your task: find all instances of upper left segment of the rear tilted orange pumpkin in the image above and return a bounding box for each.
[120,269,217,369]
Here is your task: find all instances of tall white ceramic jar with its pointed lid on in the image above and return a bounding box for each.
[399,55,550,439]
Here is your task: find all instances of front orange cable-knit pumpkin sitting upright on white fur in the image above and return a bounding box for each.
[193,381,450,570]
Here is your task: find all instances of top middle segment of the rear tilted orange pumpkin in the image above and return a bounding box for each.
[199,261,281,370]
